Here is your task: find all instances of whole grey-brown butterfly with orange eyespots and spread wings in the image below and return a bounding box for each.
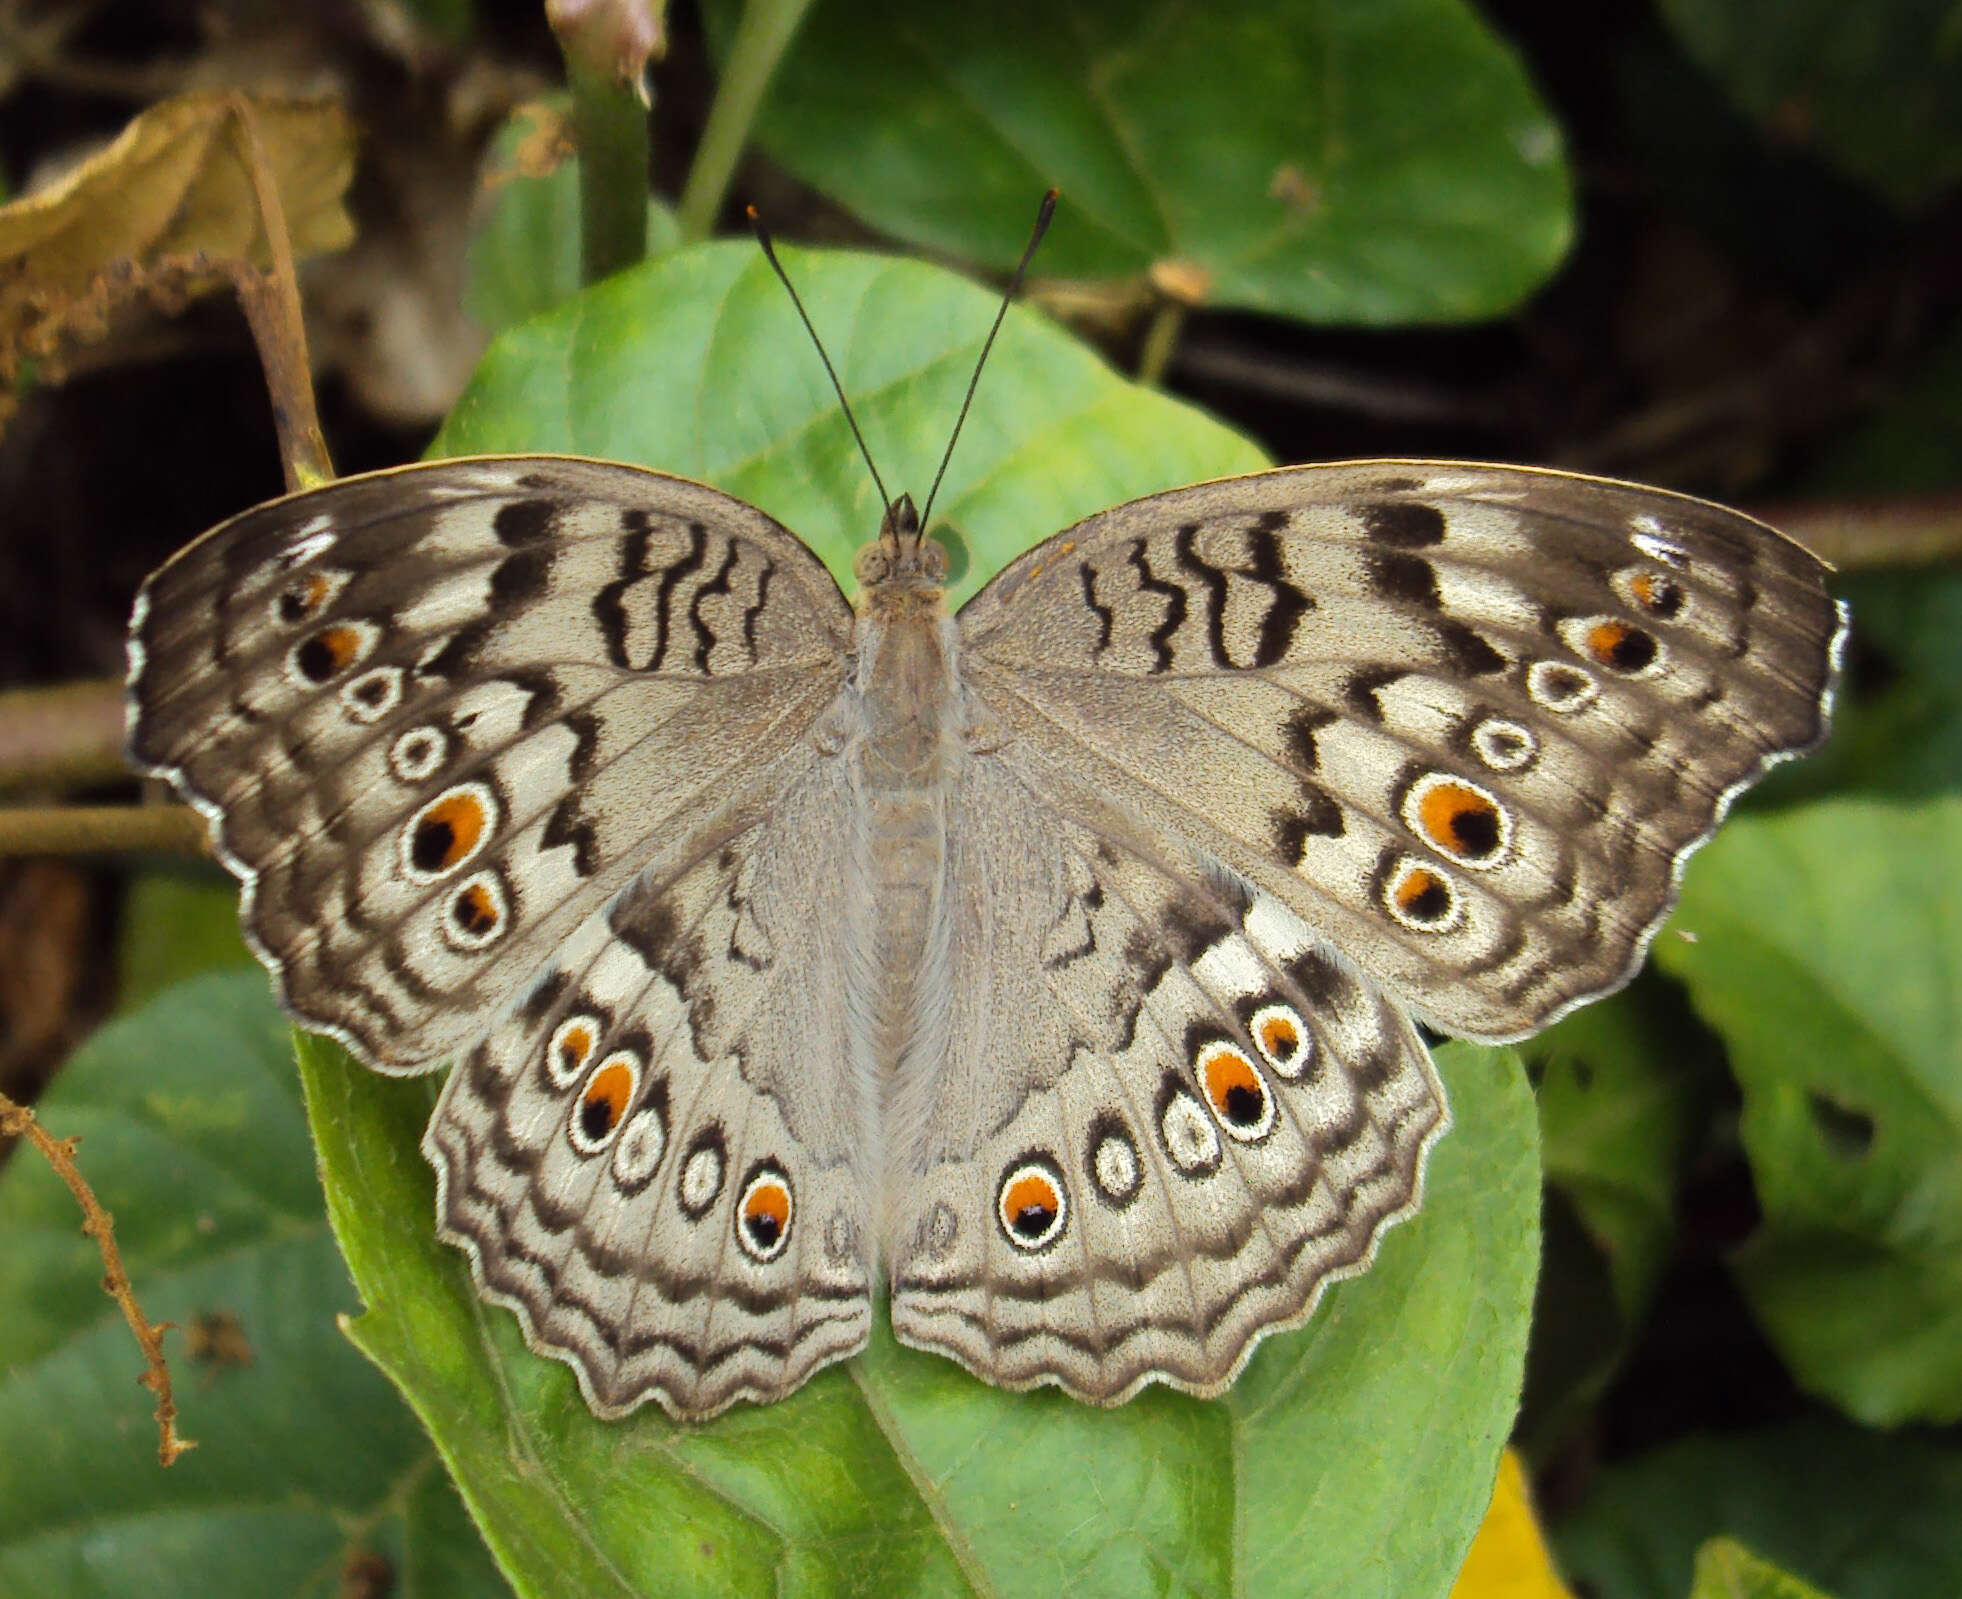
[129,443,1844,1418]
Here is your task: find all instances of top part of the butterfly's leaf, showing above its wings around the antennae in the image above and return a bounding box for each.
[430,241,1267,598]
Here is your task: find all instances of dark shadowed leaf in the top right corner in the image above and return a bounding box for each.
[1662,0,1962,208]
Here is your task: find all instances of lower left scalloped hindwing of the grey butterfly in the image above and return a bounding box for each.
[424,748,873,1418]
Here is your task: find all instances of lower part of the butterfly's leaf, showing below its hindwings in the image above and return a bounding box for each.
[302,1040,1538,1595]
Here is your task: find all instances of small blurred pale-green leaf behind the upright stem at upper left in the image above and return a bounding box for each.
[463,94,681,334]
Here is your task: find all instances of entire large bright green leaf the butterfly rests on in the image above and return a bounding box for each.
[364,245,1538,1595]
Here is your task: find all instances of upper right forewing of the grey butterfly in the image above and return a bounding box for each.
[961,461,1842,1038]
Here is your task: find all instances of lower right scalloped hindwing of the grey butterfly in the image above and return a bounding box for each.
[887,755,1448,1403]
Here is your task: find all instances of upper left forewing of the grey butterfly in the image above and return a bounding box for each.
[129,457,852,1069]
